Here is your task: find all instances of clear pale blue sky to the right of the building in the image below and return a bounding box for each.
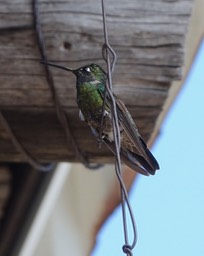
[93,39,204,256]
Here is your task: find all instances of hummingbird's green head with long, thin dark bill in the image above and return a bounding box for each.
[40,61,106,85]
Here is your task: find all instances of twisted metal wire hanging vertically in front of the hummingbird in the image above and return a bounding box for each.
[99,0,137,256]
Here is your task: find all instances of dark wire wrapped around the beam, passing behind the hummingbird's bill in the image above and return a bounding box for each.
[33,0,102,170]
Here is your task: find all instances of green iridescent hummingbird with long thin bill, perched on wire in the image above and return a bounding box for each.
[41,61,159,176]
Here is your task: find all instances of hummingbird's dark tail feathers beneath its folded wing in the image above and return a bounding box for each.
[104,138,153,176]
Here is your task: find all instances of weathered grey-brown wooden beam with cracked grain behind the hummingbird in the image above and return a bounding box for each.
[0,0,193,162]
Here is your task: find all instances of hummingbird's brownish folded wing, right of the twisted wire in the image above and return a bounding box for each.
[115,97,159,174]
